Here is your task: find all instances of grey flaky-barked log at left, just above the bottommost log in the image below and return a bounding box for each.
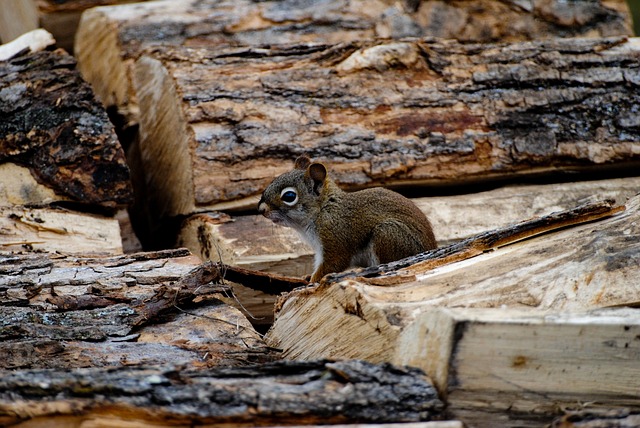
[0,249,278,369]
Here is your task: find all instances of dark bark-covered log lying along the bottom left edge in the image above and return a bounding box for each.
[0,361,443,428]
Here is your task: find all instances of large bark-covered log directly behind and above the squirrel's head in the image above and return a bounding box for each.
[134,38,640,224]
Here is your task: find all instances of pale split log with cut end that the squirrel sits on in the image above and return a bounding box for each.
[267,196,640,361]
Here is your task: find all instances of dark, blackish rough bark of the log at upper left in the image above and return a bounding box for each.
[0,50,131,207]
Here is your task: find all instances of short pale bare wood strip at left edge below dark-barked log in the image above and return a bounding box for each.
[0,206,122,255]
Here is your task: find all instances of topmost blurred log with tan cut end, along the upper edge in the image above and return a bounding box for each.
[72,0,633,122]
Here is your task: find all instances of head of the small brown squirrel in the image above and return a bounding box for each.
[258,155,328,229]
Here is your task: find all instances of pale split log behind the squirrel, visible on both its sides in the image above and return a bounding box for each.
[177,177,640,277]
